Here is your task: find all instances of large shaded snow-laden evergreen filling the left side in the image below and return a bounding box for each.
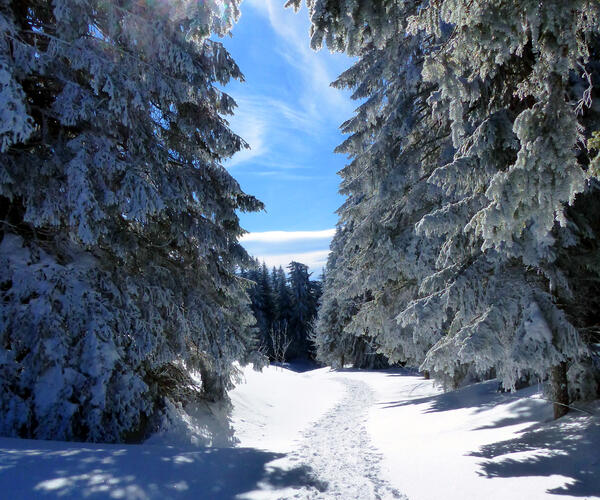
[0,0,260,441]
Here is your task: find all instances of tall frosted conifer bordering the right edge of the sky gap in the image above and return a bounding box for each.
[304,0,447,372]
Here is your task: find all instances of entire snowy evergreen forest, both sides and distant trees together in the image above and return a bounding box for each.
[0,0,600,498]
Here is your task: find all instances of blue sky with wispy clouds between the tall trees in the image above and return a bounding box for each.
[222,0,355,275]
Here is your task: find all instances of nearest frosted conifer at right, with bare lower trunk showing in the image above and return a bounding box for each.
[402,0,599,414]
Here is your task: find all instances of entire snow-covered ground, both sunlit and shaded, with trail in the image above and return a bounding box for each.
[0,367,600,500]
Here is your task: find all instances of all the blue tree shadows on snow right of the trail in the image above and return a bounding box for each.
[380,372,600,498]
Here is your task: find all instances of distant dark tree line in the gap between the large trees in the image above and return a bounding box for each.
[241,260,322,362]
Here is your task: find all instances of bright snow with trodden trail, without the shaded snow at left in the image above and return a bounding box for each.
[232,367,600,500]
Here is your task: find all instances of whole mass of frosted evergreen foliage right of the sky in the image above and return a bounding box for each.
[298,0,600,410]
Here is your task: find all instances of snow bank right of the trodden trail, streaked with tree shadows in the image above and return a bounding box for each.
[355,372,600,500]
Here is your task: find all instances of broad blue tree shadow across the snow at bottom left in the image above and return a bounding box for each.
[0,439,327,500]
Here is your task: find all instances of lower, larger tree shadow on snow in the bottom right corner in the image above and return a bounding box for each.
[470,416,600,497]
